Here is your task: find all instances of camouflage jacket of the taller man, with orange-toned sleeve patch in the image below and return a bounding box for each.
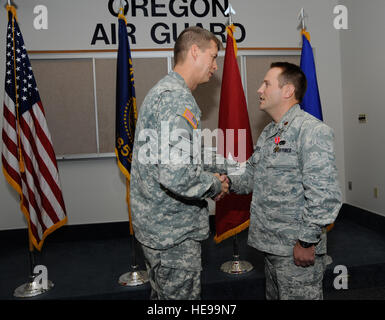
[130,72,221,249]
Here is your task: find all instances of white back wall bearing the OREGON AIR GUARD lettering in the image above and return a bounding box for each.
[0,0,345,230]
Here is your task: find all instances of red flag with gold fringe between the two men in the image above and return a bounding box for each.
[214,25,253,243]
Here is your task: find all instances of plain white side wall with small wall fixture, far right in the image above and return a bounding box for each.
[340,0,385,215]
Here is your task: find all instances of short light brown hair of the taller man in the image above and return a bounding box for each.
[174,27,223,65]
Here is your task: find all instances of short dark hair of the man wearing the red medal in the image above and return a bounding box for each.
[270,62,307,102]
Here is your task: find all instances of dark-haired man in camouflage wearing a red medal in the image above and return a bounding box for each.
[229,62,341,299]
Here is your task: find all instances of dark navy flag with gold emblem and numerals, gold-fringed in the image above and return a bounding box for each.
[115,13,137,181]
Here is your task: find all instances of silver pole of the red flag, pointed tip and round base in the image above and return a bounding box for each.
[220,4,254,274]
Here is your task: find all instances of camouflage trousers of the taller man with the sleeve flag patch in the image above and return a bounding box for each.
[142,239,202,300]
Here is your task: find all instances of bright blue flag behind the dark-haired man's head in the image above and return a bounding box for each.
[300,30,323,121]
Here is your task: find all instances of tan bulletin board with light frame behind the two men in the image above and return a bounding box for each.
[30,49,300,160]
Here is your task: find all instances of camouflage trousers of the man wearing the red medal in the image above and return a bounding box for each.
[265,254,326,300]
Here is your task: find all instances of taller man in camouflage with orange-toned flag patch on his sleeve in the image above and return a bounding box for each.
[130,27,228,300]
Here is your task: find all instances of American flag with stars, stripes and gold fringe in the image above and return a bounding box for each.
[1,6,67,250]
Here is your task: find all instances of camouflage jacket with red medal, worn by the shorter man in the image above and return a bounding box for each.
[230,105,341,256]
